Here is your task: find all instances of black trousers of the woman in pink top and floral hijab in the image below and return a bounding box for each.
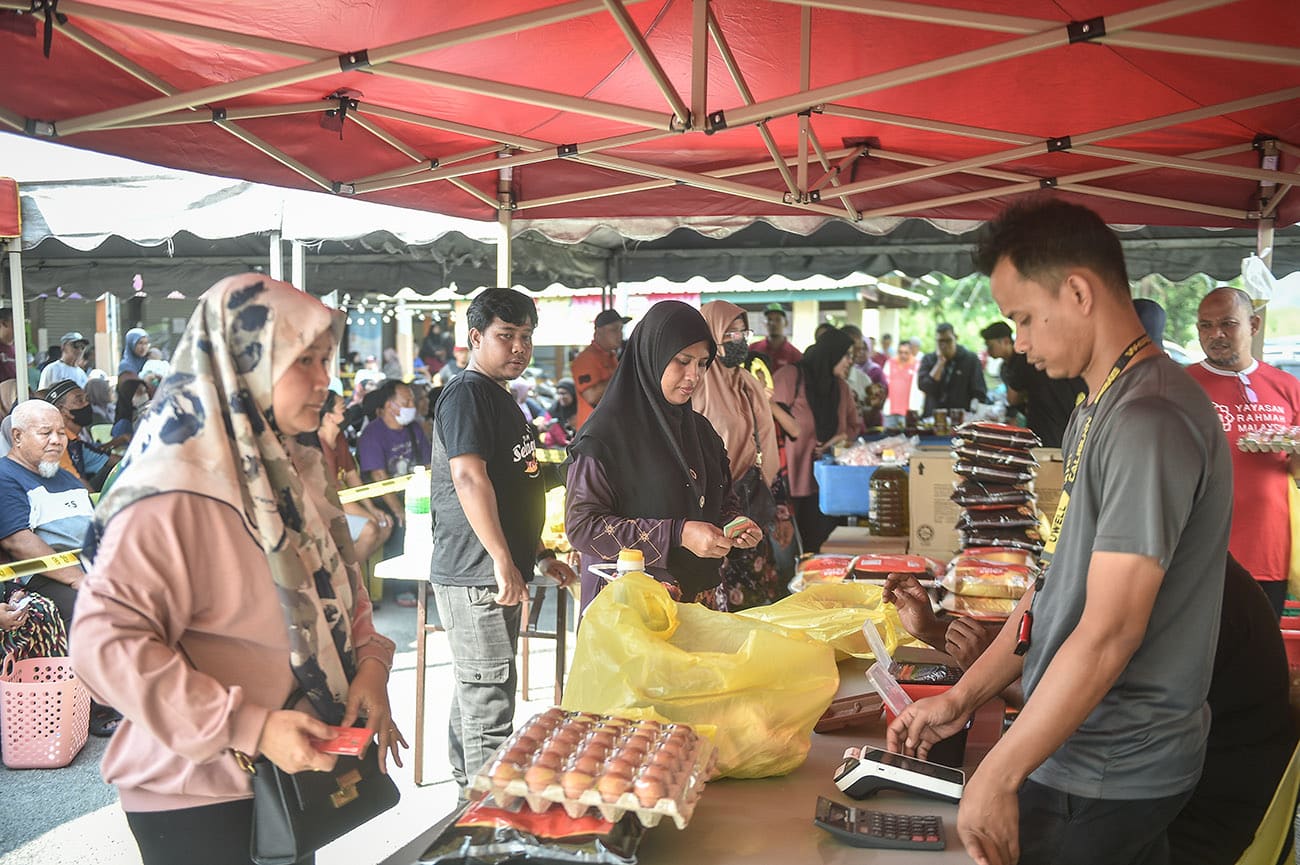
[126,799,316,865]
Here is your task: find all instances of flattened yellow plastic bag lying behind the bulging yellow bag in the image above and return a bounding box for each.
[736,583,915,659]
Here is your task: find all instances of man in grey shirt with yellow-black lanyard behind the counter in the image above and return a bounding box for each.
[888,199,1232,865]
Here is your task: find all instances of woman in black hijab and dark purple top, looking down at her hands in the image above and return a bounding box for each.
[564,300,762,609]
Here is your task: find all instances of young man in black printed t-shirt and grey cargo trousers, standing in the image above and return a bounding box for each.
[429,289,576,799]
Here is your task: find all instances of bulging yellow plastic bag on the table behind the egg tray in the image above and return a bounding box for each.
[564,574,840,778]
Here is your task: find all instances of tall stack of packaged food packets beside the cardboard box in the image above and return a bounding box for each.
[940,421,1043,618]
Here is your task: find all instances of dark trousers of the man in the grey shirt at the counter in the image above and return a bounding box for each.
[1019,780,1192,865]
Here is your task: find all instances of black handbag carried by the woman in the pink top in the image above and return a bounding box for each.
[237,691,400,865]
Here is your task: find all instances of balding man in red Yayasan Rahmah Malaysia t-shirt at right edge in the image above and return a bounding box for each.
[1187,287,1300,618]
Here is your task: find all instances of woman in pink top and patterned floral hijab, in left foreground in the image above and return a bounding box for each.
[70,273,404,865]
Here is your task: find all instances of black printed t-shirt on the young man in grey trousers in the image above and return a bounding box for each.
[430,369,546,585]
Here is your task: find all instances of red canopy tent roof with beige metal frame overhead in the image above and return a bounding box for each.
[0,0,1300,232]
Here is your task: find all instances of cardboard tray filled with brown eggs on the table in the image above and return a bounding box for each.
[469,709,718,829]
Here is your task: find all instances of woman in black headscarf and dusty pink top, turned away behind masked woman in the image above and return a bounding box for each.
[772,328,859,553]
